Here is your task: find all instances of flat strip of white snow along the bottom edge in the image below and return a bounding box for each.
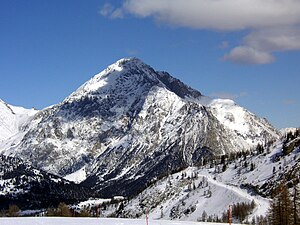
[0,217,240,225]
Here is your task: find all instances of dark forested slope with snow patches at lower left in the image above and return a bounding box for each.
[0,154,95,211]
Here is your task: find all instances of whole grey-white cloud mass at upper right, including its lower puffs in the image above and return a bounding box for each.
[100,0,300,64]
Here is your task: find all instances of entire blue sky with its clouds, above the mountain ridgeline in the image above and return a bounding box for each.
[0,0,300,128]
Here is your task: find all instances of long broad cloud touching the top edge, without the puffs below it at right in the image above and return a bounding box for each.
[122,0,300,30]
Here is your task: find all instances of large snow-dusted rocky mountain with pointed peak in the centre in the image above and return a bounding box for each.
[0,58,280,196]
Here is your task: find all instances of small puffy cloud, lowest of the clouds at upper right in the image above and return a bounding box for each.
[224,46,275,64]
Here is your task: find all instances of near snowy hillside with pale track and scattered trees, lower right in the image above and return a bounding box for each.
[103,132,300,221]
